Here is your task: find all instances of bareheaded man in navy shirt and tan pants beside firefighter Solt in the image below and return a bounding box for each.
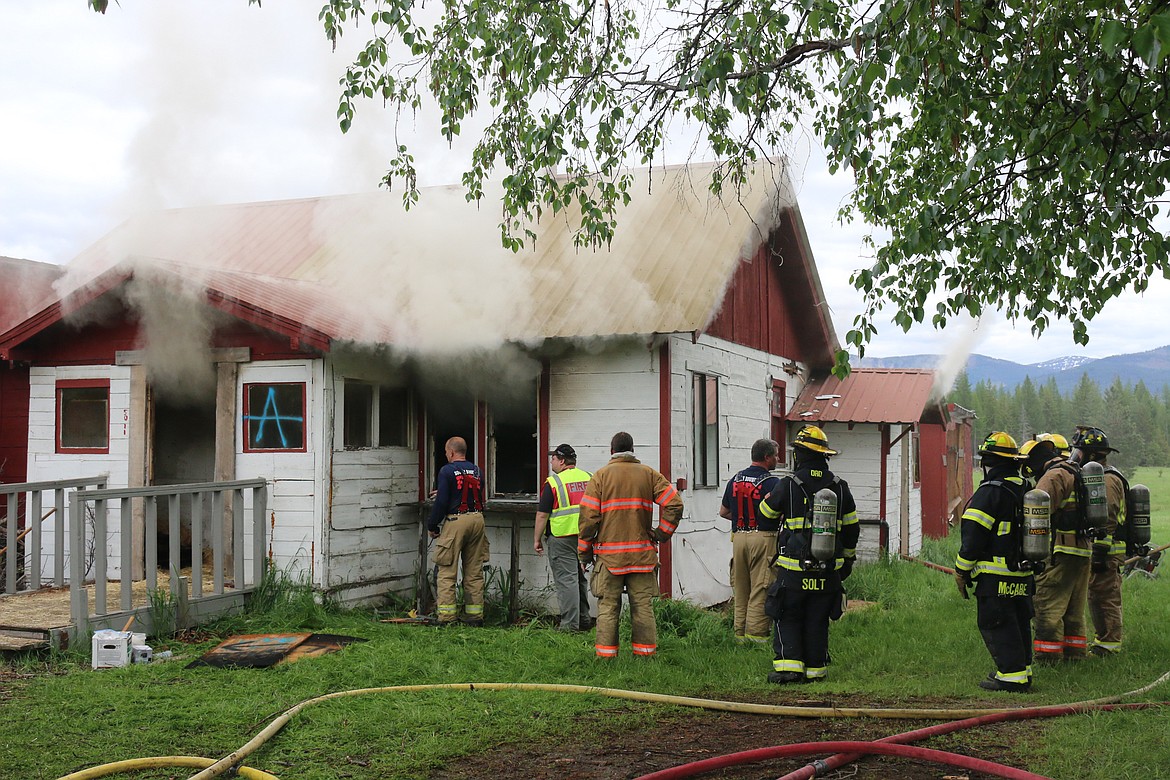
[720,439,780,642]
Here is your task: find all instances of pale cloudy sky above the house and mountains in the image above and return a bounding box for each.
[0,0,1170,363]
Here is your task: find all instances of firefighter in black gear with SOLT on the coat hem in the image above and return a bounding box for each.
[759,426,861,684]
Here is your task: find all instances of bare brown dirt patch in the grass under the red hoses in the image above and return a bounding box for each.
[431,700,1025,780]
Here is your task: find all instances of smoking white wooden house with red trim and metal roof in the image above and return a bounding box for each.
[0,165,968,603]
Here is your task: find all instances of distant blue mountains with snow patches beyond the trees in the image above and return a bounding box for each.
[854,345,1170,393]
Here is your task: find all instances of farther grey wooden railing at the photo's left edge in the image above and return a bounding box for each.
[0,474,109,593]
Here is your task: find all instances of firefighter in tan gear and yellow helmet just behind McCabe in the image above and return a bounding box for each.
[1020,439,1090,663]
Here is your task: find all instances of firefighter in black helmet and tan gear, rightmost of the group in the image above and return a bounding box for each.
[1072,426,1129,656]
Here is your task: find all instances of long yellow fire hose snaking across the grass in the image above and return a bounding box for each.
[60,671,1170,780]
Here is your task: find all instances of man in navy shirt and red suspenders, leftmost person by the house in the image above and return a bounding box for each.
[427,436,489,626]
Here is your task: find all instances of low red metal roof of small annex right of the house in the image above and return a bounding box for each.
[789,368,942,423]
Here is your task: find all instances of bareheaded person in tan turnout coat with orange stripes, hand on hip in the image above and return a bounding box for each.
[577,432,682,658]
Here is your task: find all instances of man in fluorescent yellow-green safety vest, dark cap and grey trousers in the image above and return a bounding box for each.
[532,444,593,631]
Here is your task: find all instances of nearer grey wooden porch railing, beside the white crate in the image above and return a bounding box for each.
[69,479,268,635]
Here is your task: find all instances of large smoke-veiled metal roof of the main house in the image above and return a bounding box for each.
[0,161,837,361]
